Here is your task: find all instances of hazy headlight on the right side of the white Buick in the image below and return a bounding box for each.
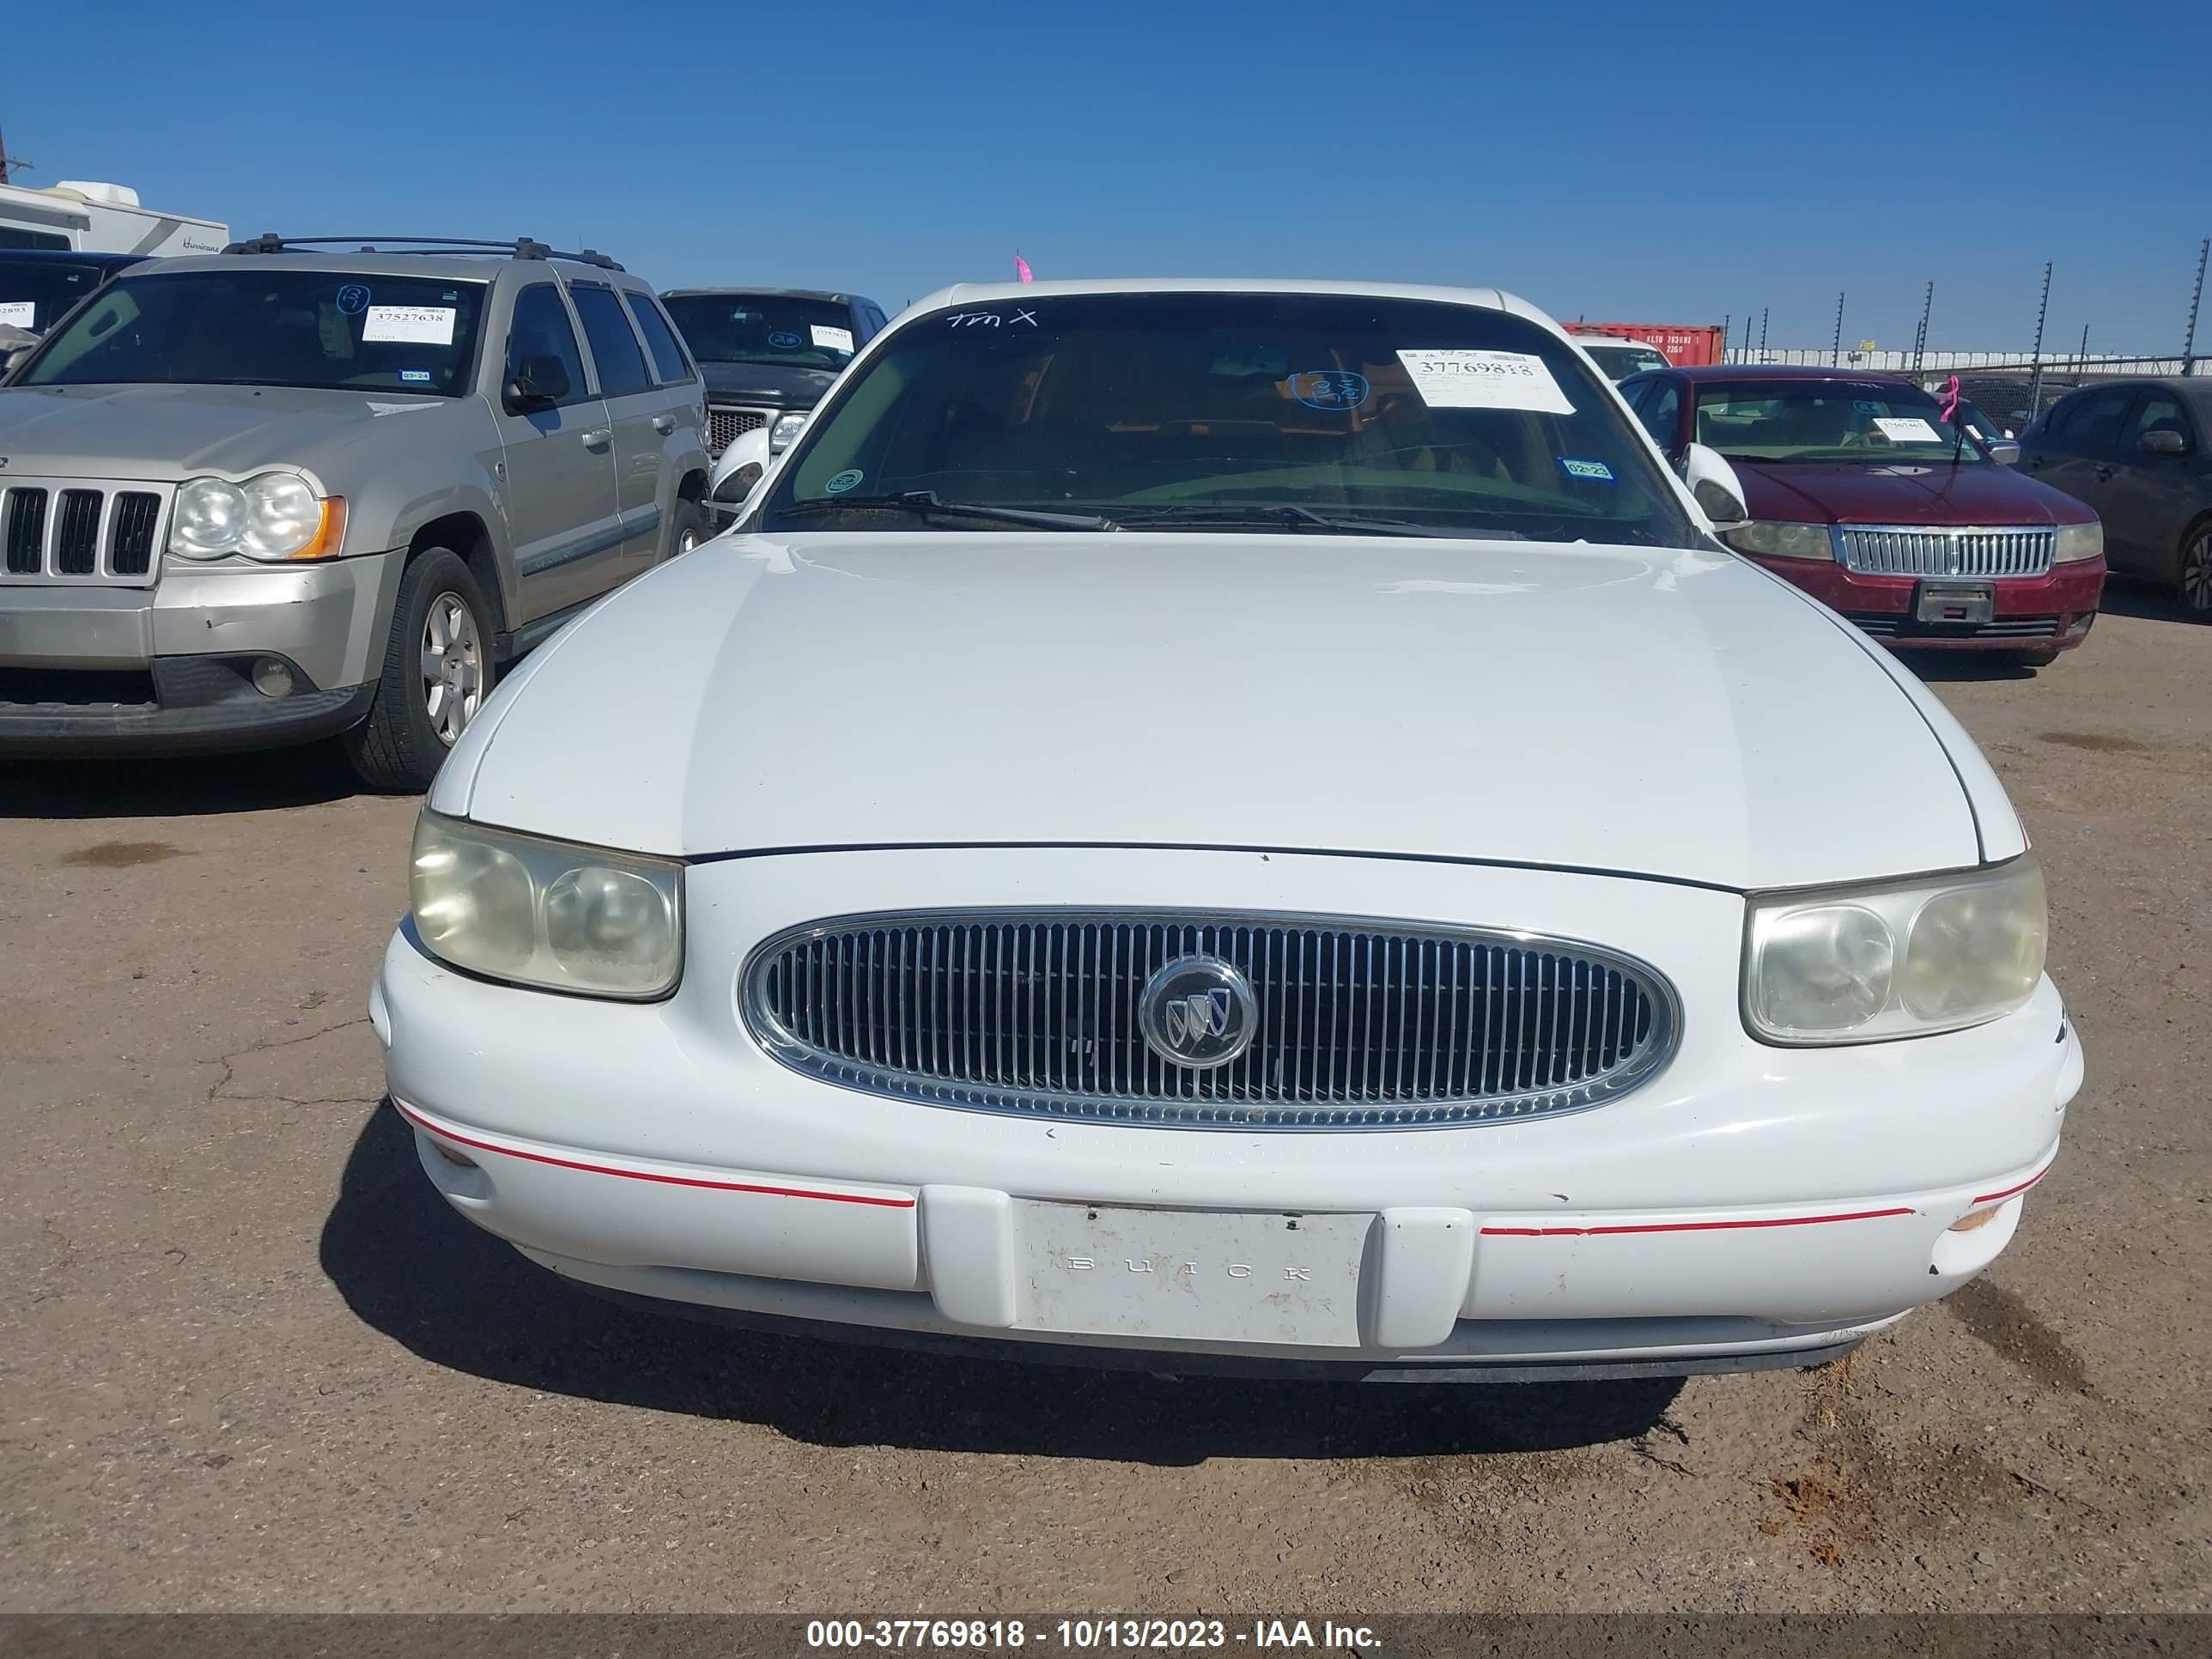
[1743,858,2048,1044]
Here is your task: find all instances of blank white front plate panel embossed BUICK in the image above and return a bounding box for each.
[1015,1201,1374,1347]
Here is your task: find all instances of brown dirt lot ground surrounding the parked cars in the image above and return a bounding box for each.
[0,595,2212,1614]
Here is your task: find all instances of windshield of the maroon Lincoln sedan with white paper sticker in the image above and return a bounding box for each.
[1697,380,1986,465]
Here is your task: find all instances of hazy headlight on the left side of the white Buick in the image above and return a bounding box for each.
[410,811,684,1002]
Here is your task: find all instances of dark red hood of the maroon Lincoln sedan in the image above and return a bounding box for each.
[1729,460,2097,525]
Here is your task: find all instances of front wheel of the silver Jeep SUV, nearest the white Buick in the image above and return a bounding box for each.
[345,546,495,792]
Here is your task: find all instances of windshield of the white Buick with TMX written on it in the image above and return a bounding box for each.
[761,295,1697,546]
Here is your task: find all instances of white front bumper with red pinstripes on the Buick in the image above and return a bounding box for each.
[372,849,2081,1370]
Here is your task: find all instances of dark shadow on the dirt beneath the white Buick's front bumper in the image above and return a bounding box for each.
[321,1102,1683,1467]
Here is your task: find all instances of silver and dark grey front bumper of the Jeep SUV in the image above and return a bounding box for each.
[0,553,403,757]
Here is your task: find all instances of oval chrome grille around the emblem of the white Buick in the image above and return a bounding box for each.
[744,911,1679,1130]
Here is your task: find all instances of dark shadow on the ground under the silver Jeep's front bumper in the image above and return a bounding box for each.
[0,744,362,818]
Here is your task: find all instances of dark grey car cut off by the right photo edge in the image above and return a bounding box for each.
[2020,376,2212,622]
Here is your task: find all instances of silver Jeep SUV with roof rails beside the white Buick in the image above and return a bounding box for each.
[0,237,708,790]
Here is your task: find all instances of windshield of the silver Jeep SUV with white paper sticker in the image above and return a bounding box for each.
[15,276,484,396]
